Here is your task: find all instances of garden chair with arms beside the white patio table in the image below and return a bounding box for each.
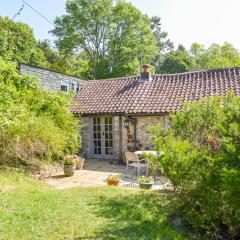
[125,152,148,178]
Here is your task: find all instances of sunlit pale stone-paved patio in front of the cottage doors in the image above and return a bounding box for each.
[47,160,170,190]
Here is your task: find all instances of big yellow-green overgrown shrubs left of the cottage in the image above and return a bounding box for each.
[0,58,79,169]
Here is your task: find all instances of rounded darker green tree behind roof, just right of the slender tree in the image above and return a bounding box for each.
[161,45,194,73]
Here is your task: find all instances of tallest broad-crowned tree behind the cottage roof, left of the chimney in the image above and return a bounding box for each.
[52,0,156,78]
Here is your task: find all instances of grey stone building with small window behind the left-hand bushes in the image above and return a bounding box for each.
[19,63,84,92]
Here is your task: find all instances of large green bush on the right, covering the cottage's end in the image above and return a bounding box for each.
[152,93,240,239]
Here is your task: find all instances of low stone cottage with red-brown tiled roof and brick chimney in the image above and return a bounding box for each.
[71,65,240,162]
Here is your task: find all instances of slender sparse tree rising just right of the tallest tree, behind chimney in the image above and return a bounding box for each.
[151,16,174,73]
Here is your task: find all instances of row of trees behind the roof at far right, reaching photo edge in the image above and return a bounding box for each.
[160,43,240,73]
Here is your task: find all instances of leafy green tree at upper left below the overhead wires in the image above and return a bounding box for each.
[0,17,45,64]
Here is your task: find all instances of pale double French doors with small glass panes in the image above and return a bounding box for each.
[91,116,114,159]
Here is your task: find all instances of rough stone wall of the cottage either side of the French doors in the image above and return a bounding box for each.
[82,116,168,162]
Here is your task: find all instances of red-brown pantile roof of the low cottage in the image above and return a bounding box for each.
[70,67,240,114]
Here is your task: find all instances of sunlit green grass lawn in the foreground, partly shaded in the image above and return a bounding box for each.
[0,172,187,240]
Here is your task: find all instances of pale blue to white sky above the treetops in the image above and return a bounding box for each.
[0,0,240,49]
